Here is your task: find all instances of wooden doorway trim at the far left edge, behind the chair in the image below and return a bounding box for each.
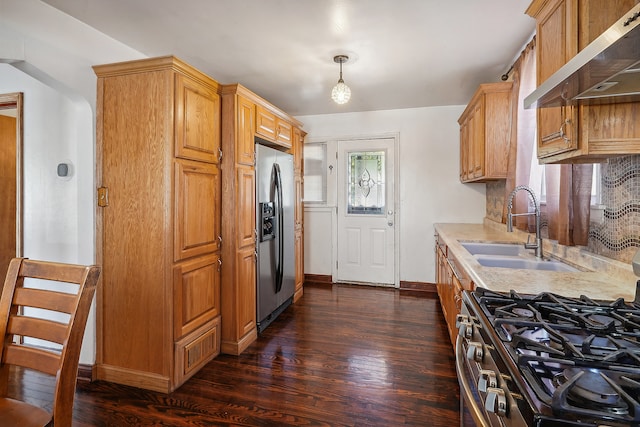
[0,92,24,257]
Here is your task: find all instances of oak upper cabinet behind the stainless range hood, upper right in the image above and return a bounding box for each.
[526,0,640,163]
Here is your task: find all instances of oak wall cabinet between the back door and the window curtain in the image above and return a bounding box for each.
[458,82,513,182]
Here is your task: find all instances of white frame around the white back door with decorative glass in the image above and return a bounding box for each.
[327,132,401,288]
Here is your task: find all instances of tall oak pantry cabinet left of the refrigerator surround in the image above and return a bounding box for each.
[94,56,222,392]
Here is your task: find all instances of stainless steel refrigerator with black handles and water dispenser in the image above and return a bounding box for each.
[256,144,295,332]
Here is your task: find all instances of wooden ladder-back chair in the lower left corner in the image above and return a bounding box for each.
[0,258,100,427]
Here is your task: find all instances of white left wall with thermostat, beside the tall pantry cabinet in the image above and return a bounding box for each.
[0,0,144,364]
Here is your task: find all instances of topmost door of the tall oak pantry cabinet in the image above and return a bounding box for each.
[174,74,220,163]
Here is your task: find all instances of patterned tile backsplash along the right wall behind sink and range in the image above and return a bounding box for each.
[486,155,640,263]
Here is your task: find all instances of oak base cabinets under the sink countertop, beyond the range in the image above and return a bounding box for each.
[435,234,474,349]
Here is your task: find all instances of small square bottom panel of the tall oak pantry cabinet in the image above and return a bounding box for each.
[175,316,220,388]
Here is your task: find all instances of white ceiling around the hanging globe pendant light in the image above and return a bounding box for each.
[43,0,535,115]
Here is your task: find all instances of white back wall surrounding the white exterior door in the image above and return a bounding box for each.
[297,106,485,283]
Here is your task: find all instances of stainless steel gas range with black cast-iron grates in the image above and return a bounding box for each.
[456,288,640,427]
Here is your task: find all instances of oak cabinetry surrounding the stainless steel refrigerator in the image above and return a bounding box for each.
[221,84,303,355]
